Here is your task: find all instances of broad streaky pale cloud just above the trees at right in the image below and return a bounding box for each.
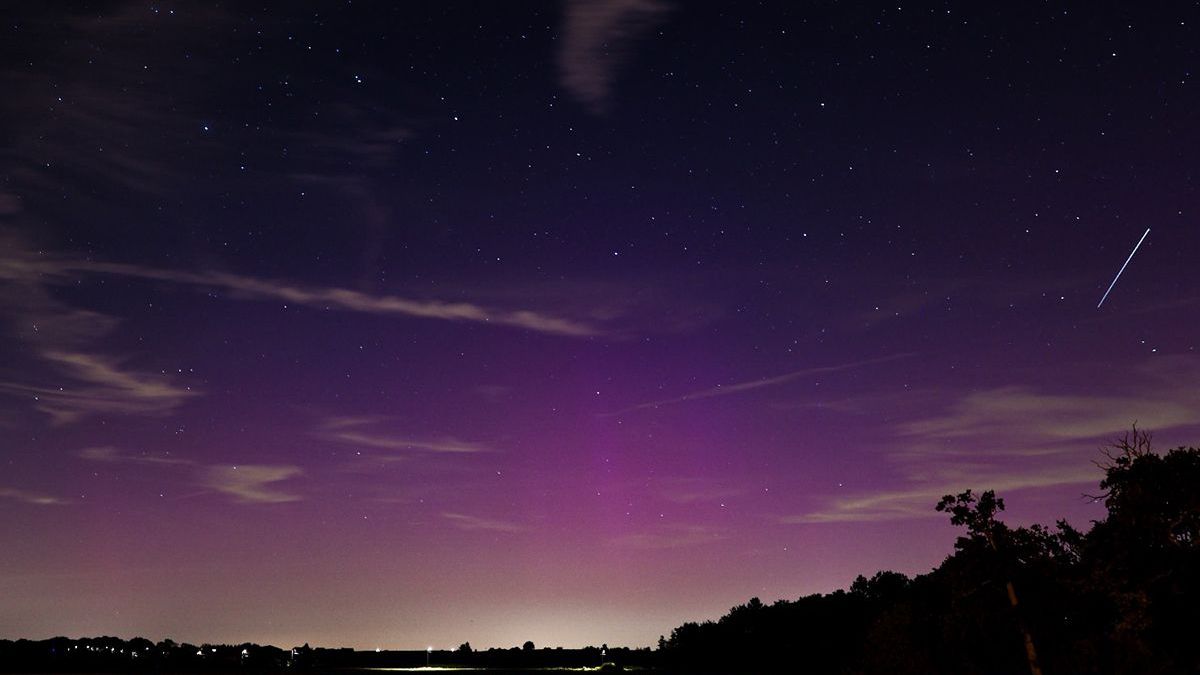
[780,356,1200,524]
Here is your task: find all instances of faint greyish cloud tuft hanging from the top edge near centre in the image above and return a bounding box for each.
[558,0,671,113]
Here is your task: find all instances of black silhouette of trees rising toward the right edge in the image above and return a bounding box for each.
[658,428,1200,675]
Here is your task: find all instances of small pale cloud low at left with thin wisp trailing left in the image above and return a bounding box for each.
[78,446,304,504]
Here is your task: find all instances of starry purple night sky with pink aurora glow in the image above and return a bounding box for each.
[0,0,1200,649]
